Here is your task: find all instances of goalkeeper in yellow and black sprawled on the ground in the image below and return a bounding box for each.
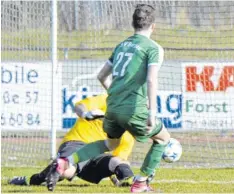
[9,94,134,186]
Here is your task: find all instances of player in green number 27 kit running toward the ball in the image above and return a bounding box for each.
[47,4,170,192]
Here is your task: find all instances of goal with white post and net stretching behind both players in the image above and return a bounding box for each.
[1,0,234,168]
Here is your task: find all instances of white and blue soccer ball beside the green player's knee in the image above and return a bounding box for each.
[162,138,182,163]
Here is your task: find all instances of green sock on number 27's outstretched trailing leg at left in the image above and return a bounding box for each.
[67,140,109,164]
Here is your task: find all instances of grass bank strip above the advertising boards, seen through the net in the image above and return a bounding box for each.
[2,26,234,60]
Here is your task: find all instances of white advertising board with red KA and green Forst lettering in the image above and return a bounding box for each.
[182,62,234,130]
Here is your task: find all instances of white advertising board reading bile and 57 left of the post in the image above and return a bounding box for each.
[1,62,52,130]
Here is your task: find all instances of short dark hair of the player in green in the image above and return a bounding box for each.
[132,4,155,31]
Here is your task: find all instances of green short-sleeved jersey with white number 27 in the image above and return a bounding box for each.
[107,34,164,114]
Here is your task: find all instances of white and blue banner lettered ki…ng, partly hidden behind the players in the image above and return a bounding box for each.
[62,86,182,129]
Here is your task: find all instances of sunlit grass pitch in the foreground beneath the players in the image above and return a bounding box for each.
[2,168,234,193]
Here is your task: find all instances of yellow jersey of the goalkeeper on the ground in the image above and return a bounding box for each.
[62,94,134,160]
